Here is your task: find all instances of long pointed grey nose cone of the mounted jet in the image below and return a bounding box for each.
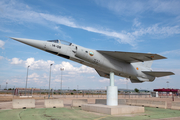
[10,37,46,50]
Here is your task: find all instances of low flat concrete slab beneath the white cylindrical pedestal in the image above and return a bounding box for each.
[81,104,144,115]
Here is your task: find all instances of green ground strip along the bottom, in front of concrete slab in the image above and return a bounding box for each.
[0,107,180,120]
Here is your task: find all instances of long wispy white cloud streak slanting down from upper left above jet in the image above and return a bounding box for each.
[0,1,138,46]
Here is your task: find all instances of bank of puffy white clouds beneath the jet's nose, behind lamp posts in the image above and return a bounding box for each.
[10,58,96,76]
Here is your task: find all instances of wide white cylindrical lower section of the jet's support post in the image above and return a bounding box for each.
[106,86,118,106]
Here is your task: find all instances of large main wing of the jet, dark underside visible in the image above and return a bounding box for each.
[97,50,166,63]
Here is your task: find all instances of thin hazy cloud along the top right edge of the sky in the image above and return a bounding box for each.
[96,0,180,16]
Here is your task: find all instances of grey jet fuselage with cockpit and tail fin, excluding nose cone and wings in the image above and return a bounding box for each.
[44,41,155,82]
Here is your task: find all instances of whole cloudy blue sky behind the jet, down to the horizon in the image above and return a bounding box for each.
[0,0,180,90]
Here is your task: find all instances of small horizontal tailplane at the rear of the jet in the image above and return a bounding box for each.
[142,71,174,77]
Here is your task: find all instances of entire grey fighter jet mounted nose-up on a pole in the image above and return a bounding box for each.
[11,38,174,83]
